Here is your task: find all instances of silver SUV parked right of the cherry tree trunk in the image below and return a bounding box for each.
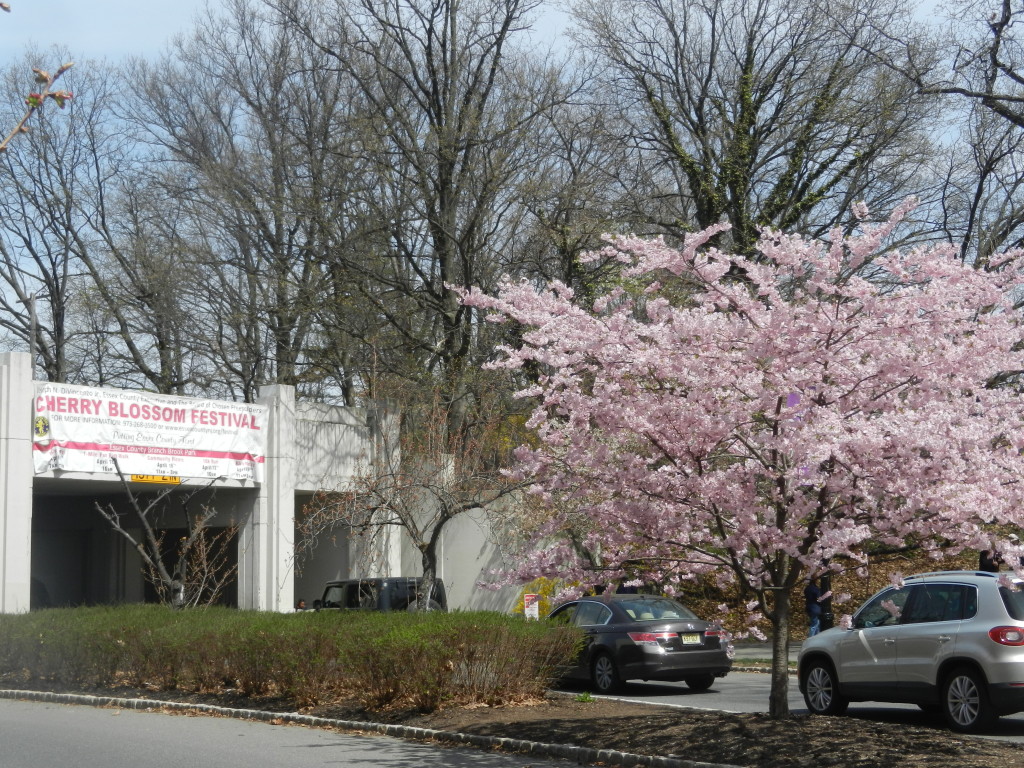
[799,571,1024,732]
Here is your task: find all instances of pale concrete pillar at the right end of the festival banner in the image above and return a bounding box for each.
[239,384,296,611]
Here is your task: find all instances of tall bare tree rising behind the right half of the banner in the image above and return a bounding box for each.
[132,0,368,400]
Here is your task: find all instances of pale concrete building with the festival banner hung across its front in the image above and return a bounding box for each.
[0,352,516,613]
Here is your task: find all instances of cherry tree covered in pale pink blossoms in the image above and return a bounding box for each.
[464,203,1024,717]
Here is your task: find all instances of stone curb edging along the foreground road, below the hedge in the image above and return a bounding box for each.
[0,689,741,768]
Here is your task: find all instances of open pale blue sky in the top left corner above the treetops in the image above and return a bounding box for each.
[0,0,216,60]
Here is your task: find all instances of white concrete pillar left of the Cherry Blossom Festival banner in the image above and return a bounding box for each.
[0,352,34,613]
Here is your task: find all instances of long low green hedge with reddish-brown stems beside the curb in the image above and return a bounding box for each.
[0,605,579,712]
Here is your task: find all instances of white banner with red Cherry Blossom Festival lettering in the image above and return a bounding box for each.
[32,383,267,482]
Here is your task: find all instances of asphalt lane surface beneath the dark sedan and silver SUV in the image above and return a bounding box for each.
[569,672,1024,743]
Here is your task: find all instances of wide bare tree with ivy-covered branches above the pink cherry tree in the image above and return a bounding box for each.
[574,0,929,252]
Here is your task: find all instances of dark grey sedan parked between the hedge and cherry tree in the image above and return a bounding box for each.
[549,594,732,693]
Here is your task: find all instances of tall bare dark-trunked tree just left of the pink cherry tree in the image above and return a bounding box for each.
[270,0,577,431]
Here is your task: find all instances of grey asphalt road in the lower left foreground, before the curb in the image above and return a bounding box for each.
[0,699,567,768]
